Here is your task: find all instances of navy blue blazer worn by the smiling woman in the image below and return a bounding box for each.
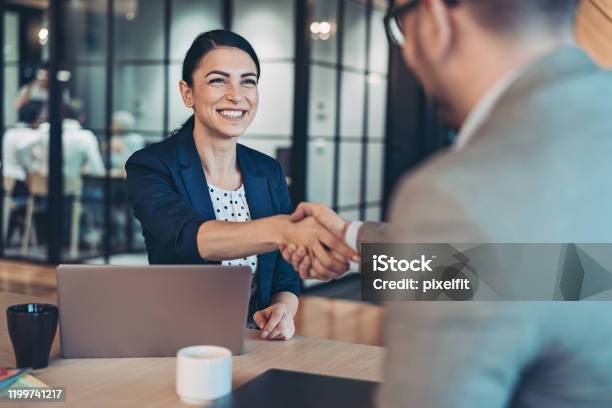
[125,126,300,308]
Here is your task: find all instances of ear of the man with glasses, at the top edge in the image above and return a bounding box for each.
[422,0,455,61]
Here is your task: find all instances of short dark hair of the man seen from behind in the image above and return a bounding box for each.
[465,0,578,32]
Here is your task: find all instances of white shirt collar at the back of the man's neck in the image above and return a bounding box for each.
[452,66,526,151]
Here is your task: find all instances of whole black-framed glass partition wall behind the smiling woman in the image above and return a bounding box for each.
[0,0,388,264]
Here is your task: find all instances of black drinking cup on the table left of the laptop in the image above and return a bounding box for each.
[6,303,58,368]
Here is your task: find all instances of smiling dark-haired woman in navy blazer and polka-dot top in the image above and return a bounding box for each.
[126,30,356,339]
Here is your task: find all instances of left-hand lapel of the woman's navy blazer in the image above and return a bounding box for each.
[177,129,215,220]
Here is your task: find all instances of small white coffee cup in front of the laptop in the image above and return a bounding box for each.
[176,346,232,405]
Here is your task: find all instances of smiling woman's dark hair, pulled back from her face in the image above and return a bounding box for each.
[178,30,261,132]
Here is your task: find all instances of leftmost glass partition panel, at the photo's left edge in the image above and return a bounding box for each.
[0,1,49,260]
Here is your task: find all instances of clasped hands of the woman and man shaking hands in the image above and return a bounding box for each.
[279,203,360,281]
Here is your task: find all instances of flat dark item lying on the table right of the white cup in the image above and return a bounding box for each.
[212,369,379,408]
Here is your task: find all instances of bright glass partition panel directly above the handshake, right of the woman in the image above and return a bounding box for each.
[306,0,389,221]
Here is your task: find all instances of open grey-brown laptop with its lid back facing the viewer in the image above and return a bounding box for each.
[57,265,251,358]
